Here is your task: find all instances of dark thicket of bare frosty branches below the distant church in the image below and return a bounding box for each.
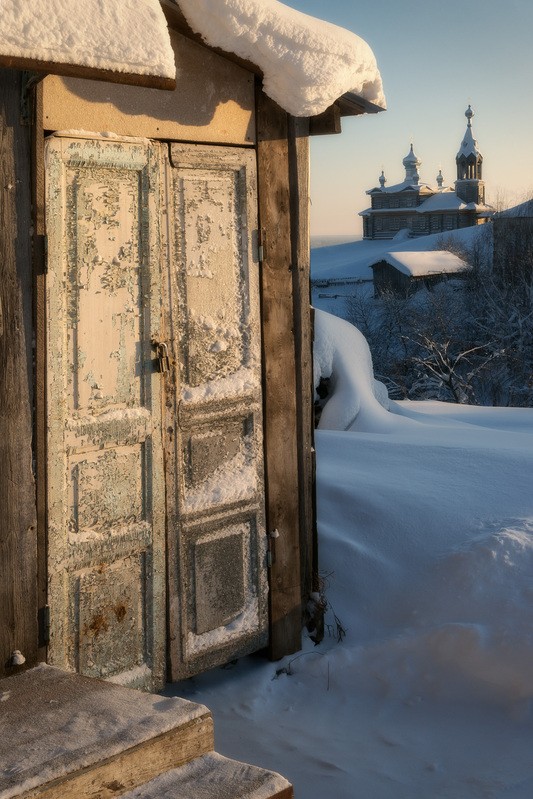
[347,225,533,407]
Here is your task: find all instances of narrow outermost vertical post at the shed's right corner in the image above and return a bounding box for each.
[289,117,318,607]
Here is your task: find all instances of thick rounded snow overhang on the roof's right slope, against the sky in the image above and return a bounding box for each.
[176,0,385,116]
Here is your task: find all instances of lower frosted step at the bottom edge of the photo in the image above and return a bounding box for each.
[122,752,294,799]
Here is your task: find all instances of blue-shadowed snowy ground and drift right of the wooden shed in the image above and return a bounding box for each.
[168,312,533,799]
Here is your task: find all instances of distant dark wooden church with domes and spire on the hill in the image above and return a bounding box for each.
[360,106,492,239]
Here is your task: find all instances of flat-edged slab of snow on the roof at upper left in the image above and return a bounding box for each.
[0,0,176,80]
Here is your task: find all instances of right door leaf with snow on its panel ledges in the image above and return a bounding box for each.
[165,144,268,679]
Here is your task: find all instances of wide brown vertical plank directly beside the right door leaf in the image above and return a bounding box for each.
[257,90,310,659]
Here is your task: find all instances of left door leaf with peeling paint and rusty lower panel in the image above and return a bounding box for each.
[46,137,165,688]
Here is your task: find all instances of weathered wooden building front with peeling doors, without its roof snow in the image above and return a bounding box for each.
[0,0,380,688]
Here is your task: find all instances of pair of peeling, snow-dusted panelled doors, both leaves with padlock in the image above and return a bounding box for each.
[46,136,268,688]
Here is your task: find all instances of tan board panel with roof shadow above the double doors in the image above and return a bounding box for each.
[43,31,255,145]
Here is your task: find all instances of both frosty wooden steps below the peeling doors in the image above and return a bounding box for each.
[0,665,292,799]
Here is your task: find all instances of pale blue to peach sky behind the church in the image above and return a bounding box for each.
[284,0,533,235]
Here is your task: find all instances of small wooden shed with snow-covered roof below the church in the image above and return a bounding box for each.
[371,250,468,299]
